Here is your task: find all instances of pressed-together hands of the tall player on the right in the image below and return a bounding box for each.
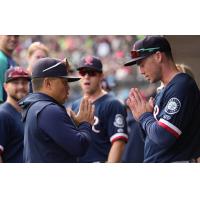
[126,88,154,121]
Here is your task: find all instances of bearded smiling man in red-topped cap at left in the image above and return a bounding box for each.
[0,67,30,163]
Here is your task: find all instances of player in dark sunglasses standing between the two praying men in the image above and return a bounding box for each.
[71,56,128,162]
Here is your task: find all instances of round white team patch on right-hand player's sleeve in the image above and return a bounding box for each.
[165,97,181,115]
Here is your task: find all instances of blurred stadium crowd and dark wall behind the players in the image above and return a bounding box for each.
[14,35,200,104]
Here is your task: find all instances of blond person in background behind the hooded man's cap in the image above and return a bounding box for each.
[27,42,49,74]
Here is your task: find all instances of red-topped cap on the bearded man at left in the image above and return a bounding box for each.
[5,66,31,83]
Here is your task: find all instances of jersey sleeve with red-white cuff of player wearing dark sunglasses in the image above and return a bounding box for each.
[104,100,128,143]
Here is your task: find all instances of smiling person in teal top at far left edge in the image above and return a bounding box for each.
[0,35,19,102]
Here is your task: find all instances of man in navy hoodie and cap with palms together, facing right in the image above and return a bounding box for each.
[20,57,94,163]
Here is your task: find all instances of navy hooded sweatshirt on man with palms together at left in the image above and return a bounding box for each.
[20,93,91,163]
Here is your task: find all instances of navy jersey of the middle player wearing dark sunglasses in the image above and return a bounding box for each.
[72,94,128,162]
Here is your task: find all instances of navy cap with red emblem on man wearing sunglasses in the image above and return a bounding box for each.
[77,56,103,72]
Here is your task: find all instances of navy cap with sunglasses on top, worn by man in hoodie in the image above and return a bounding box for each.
[31,57,80,82]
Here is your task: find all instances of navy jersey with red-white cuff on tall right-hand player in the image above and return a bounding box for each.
[140,73,200,162]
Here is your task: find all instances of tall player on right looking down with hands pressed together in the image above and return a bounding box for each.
[125,36,200,162]
